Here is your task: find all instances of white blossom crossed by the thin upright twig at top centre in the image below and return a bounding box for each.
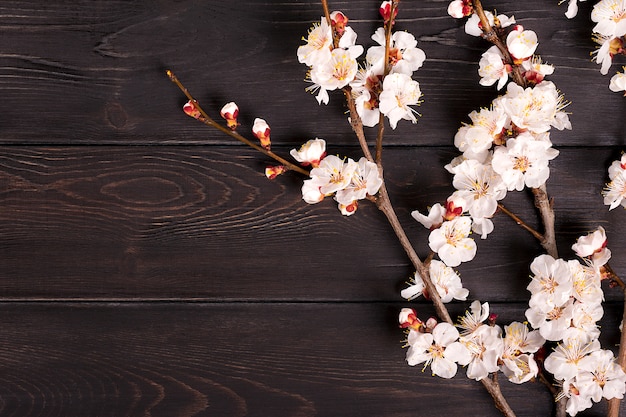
[365,27,426,76]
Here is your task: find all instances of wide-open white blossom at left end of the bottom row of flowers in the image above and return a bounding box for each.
[406,322,471,378]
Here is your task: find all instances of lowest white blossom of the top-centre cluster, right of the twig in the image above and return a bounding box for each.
[379,74,422,129]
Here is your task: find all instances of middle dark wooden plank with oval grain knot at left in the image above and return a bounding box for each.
[0,146,626,301]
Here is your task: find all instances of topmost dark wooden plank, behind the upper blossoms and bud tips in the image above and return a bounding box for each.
[0,0,624,146]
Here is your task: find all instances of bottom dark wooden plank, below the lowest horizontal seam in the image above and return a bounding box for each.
[0,303,626,417]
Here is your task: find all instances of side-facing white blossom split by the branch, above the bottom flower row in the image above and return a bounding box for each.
[400,259,469,303]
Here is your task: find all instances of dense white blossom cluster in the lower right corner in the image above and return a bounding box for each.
[526,227,626,415]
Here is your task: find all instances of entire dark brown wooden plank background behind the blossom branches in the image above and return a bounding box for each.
[0,0,626,417]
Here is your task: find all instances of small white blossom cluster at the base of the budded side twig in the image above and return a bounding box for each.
[291,138,383,216]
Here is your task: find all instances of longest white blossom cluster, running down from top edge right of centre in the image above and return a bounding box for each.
[412,6,571,267]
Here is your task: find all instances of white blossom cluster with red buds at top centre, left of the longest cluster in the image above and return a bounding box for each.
[298,1,426,129]
